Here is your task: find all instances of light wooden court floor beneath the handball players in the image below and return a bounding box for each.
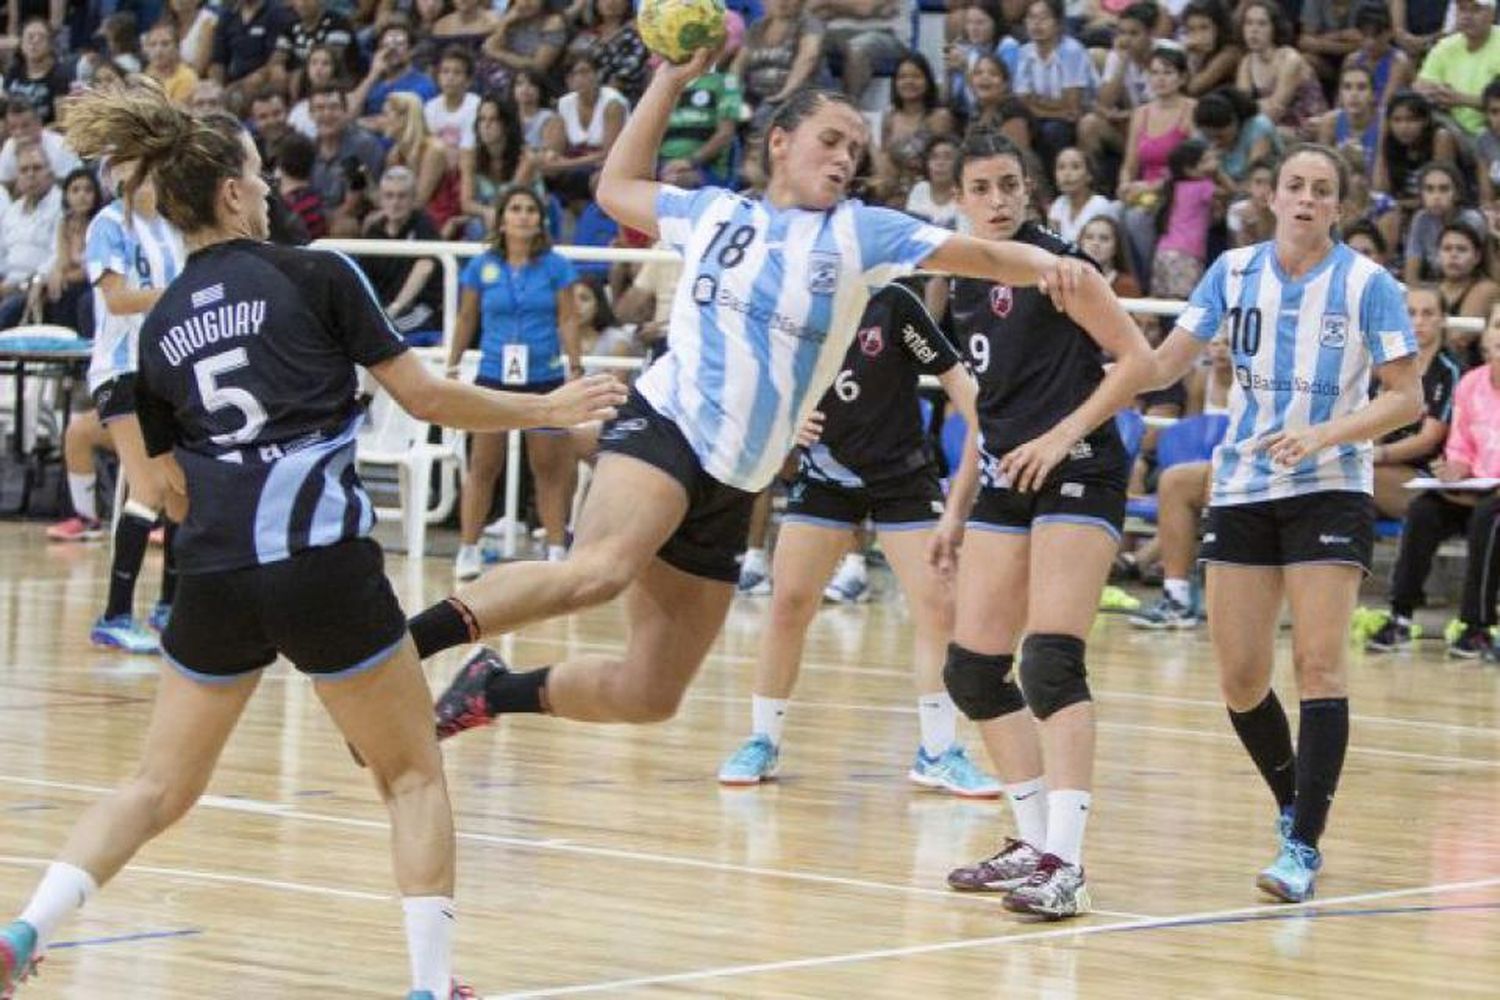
[0,523,1500,1000]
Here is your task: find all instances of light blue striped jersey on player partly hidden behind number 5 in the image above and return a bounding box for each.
[84,198,188,393]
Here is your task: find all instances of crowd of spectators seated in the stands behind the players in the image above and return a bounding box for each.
[0,0,1500,617]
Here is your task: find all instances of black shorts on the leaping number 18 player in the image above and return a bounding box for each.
[599,388,756,583]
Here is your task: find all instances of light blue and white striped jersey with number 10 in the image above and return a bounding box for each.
[1178,243,1416,507]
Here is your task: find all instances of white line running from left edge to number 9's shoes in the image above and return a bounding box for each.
[0,775,1149,919]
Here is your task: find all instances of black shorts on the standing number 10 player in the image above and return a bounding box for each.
[1199,490,1376,573]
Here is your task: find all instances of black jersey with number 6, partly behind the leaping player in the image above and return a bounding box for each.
[803,285,962,487]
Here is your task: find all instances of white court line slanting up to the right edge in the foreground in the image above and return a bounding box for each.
[485,877,1500,1000]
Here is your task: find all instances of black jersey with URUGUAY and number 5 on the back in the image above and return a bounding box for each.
[137,240,407,573]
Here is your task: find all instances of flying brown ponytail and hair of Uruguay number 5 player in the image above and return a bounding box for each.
[66,79,246,232]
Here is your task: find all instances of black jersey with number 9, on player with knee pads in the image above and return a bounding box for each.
[948,222,1115,459]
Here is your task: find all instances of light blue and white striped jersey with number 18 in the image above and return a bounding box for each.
[636,184,953,492]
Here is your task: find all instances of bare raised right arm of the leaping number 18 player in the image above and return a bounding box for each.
[596,49,713,237]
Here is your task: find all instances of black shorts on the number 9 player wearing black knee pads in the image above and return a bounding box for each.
[969,433,1130,538]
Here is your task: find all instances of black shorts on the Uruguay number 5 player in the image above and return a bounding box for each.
[162,538,407,684]
